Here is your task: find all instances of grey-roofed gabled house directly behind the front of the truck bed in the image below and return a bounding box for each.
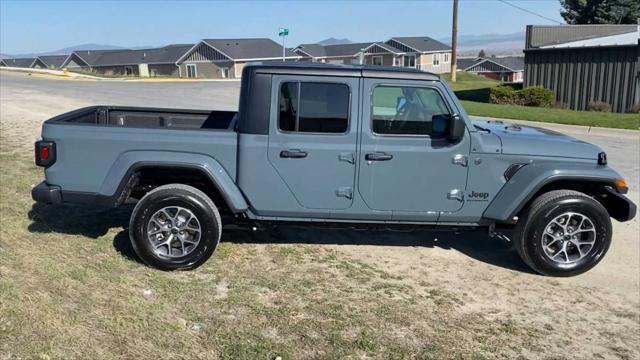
[176,38,301,79]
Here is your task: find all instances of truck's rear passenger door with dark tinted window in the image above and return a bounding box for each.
[268,75,359,211]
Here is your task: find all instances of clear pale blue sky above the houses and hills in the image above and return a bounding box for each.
[0,0,562,54]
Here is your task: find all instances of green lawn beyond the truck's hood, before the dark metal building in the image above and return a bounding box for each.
[442,72,640,130]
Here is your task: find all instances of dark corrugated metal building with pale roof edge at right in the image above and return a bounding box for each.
[524,25,640,112]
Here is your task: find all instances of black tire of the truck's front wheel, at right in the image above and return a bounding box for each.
[513,190,612,277]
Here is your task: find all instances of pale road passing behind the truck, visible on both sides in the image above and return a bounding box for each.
[0,71,640,191]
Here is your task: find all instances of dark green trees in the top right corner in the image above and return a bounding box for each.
[560,0,640,25]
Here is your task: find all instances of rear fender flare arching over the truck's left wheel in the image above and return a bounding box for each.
[98,150,249,213]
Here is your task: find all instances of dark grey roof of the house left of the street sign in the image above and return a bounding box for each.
[201,38,299,60]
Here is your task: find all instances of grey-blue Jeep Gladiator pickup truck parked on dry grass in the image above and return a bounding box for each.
[32,63,636,276]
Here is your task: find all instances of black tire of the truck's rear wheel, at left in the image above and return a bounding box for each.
[129,184,222,270]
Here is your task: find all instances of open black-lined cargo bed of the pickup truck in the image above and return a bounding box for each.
[47,106,237,130]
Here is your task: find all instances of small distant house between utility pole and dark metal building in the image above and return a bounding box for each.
[457,56,524,82]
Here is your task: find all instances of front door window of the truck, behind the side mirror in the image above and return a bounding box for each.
[371,86,450,136]
